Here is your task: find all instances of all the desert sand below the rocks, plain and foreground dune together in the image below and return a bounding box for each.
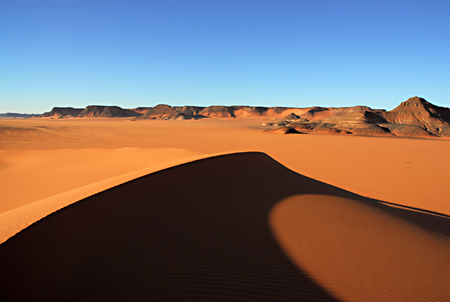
[0,118,450,301]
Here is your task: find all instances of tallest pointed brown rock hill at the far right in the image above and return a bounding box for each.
[382,96,450,135]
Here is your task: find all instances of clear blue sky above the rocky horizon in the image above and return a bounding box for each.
[0,0,450,113]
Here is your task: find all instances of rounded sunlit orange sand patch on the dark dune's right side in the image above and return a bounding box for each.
[270,194,450,301]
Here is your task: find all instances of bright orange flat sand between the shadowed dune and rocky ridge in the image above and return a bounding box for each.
[0,118,450,214]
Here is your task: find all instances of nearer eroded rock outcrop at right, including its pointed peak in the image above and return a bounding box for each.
[267,97,450,137]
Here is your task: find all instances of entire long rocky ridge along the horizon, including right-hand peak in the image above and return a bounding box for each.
[42,97,450,138]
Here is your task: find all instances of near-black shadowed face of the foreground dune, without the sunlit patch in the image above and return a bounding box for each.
[0,152,450,301]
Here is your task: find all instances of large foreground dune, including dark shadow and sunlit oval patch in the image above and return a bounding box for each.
[0,153,450,301]
